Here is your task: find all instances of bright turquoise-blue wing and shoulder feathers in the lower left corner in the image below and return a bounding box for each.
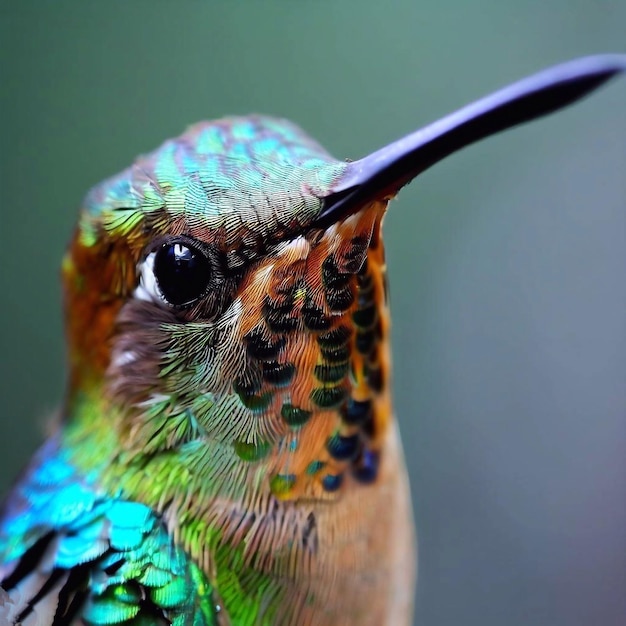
[0,441,219,626]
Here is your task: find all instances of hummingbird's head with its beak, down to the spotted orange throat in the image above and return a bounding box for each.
[59,57,624,499]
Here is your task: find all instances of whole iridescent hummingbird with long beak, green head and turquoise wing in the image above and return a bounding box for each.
[0,55,626,626]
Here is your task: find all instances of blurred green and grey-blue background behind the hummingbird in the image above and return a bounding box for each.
[0,0,626,626]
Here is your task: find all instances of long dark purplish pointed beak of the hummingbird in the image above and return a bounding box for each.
[316,55,626,225]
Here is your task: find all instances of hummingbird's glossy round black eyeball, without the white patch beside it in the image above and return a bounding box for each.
[154,242,211,306]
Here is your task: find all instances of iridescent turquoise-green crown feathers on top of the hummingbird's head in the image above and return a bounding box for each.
[80,116,346,245]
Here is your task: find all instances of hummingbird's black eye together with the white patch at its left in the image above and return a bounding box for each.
[136,240,213,306]
